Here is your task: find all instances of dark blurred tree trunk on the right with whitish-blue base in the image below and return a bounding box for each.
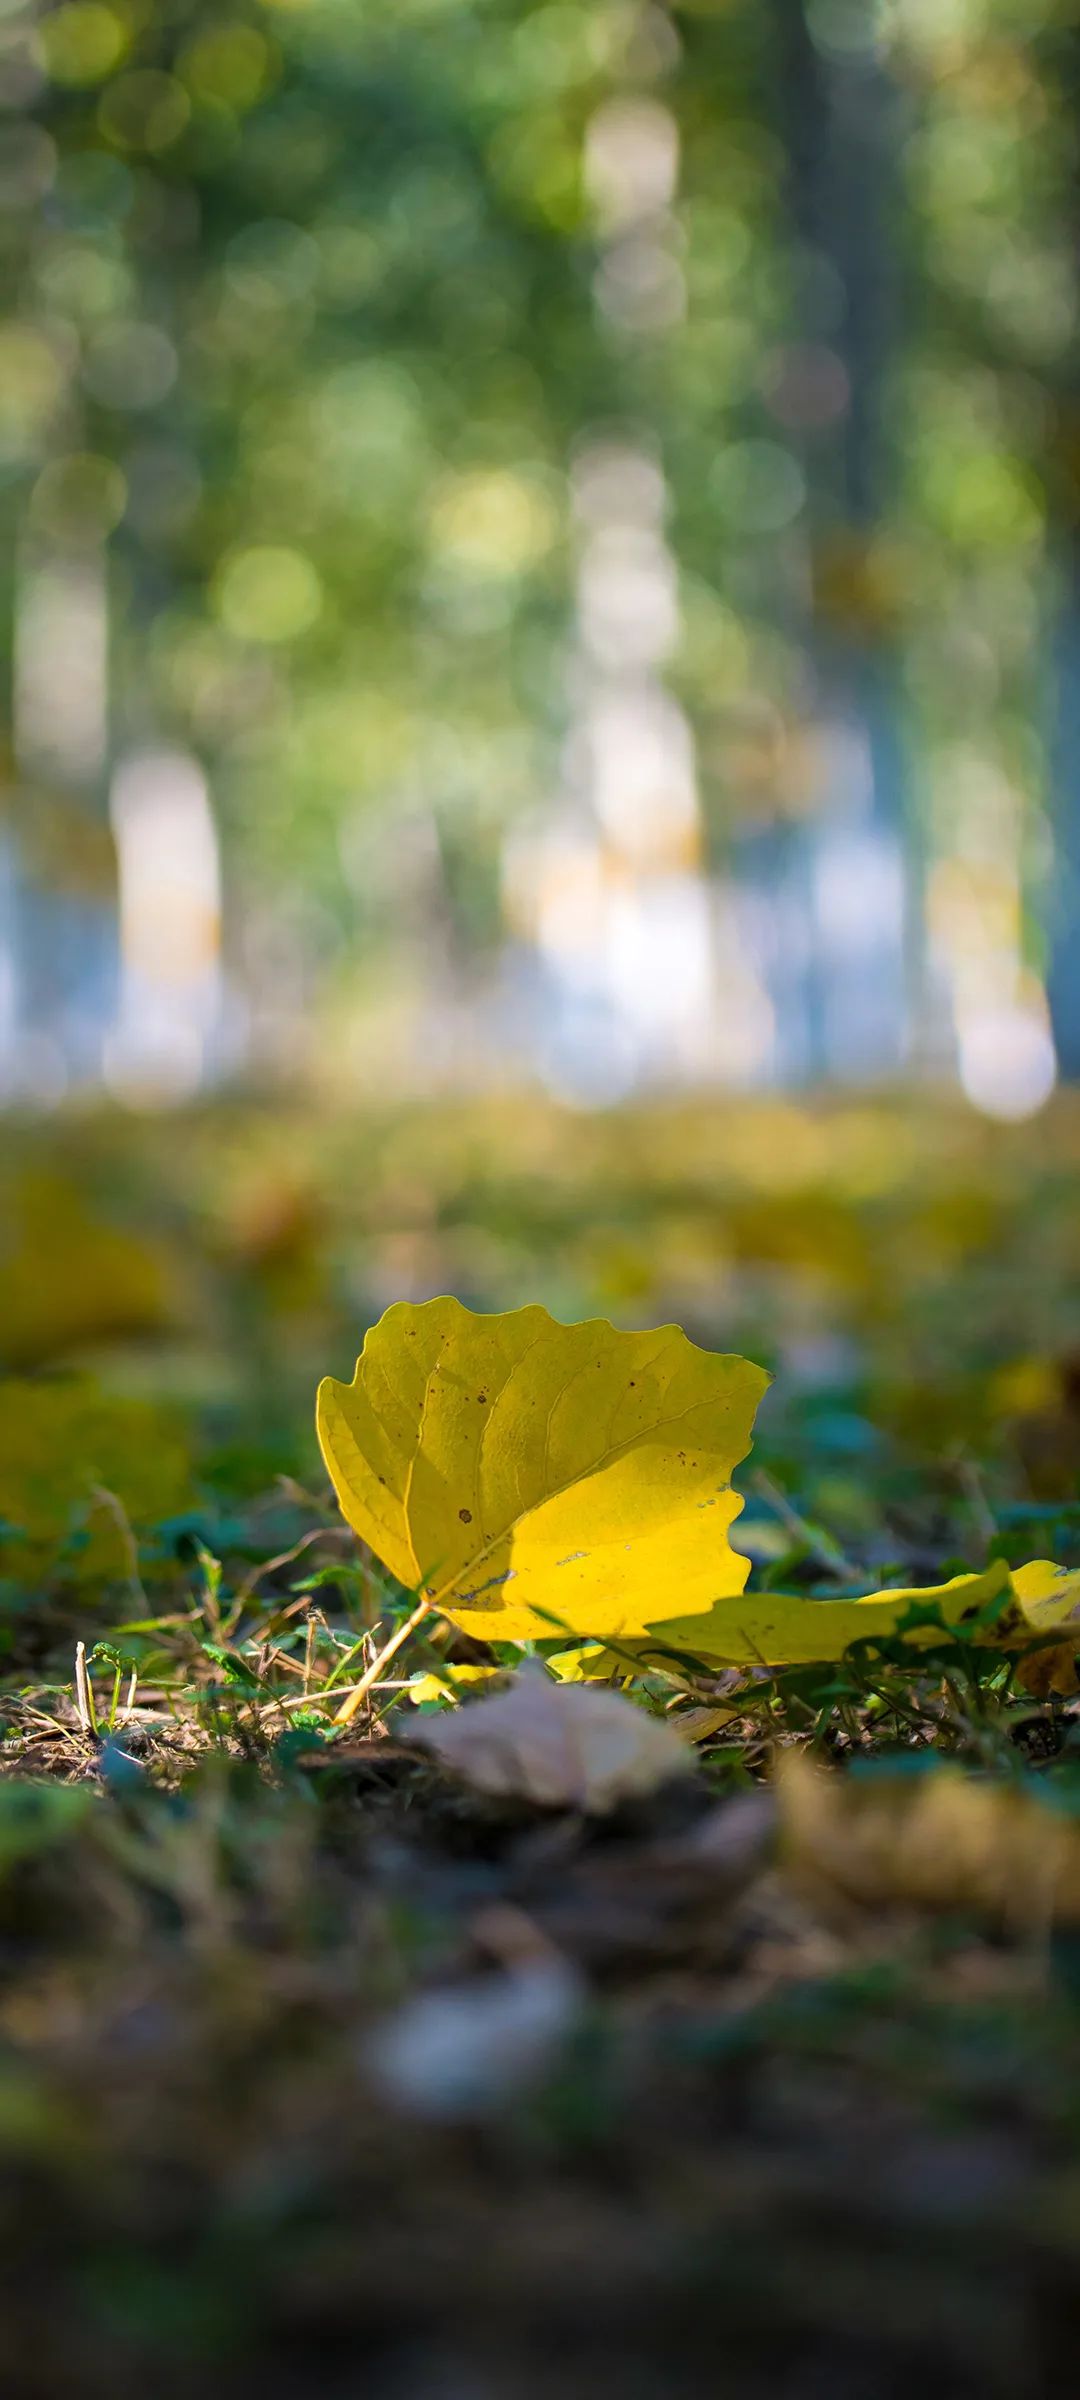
[775,0,919,1075]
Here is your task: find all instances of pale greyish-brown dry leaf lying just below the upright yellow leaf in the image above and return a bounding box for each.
[410,1668,694,1817]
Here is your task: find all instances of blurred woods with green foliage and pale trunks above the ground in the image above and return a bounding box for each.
[0,0,1080,1118]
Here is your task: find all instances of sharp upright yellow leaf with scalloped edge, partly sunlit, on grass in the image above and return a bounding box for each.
[317,1298,768,1642]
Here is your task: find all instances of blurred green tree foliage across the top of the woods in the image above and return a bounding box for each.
[0,0,1075,974]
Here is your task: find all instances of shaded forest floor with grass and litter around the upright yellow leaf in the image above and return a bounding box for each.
[0,1102,1080,2400]
